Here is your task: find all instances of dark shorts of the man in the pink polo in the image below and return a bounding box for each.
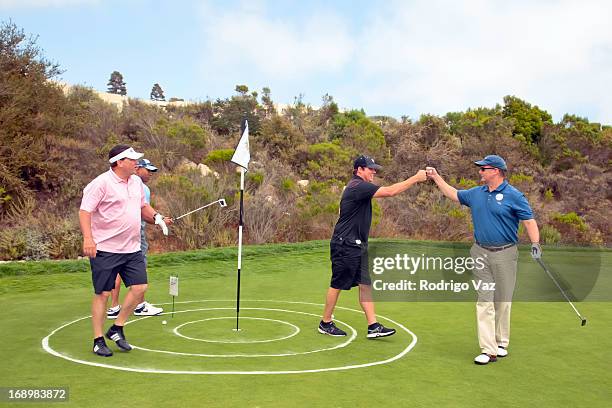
[89,251,147,295]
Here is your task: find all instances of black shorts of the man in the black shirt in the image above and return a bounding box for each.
[329,241,372,290]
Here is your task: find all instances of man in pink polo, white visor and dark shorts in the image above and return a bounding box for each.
[79,145,172,357]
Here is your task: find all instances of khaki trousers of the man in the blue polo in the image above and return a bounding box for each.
[470,244,518,355]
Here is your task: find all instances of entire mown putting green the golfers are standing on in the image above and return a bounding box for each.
[0,242,612,407]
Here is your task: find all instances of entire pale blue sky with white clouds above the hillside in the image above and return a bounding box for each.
[0,0,612,124]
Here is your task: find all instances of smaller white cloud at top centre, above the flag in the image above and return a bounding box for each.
[201,2,353,78]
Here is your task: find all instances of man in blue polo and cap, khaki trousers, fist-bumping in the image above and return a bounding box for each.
[426,155,542,365]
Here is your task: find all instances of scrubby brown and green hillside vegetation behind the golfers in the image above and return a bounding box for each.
[0,23,612,260]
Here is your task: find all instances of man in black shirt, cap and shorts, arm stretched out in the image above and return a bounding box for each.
[319,156,427,339]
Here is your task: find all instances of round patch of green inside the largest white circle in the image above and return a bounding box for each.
[42,300,417,375]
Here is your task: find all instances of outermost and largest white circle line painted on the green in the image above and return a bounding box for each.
[41,299,418,375]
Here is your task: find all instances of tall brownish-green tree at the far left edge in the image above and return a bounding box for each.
[0,22,63,212]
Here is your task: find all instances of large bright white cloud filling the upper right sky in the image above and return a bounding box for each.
[361,0,612,122]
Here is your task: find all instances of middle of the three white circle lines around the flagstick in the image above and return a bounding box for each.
[126,307,357,358]
